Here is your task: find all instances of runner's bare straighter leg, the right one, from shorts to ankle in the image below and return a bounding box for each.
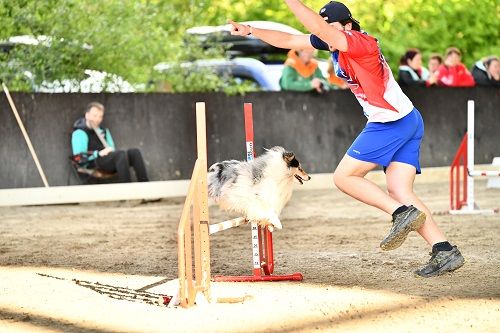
[386,162,446,246]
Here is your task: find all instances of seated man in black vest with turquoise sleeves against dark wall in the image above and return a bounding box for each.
[71,102,148,183]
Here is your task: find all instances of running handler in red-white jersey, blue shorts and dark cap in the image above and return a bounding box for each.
[229,0,464,277]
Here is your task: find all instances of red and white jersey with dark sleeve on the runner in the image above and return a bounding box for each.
[311,30,413,123]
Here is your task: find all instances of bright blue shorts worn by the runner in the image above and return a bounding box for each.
[347,108,424,173]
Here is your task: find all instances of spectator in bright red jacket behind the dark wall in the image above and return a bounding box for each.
[437,47,475,87]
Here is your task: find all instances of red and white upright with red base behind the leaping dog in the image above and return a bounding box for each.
[213,103,303,282]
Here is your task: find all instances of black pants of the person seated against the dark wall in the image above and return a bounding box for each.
[96,148,149,183]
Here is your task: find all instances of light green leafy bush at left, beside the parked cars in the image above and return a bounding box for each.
[0,0,230,91]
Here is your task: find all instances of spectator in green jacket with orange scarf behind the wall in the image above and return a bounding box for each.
[280,49,328,93]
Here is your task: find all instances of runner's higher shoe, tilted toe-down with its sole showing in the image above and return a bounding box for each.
[380,206,425,251]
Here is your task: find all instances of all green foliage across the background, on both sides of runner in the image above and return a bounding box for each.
[0,0,500,93]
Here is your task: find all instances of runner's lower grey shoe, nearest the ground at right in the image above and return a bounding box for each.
[415,246,465,277]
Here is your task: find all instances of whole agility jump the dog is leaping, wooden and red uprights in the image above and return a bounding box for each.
[177,103,303,307]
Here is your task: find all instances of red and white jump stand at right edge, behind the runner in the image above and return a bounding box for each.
[450,100,500,214]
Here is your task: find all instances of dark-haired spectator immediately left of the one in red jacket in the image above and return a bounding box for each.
[398,49,432,87]
